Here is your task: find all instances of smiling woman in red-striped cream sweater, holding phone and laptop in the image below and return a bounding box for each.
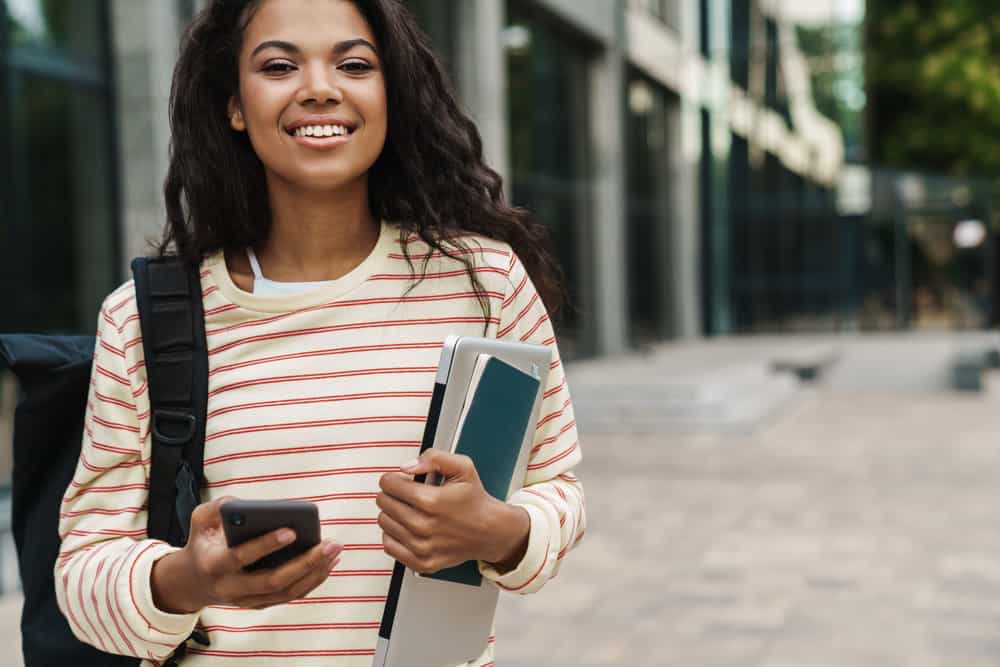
[56,0,585,667]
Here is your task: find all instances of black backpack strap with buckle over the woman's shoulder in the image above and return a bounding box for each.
[132,257,208,546]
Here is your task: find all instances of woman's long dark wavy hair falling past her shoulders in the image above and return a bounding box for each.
[158,0,566,324]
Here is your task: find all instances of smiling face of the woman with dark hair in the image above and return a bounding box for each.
[229,0,387,190]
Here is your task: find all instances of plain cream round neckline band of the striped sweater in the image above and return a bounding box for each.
[205,220,400,313]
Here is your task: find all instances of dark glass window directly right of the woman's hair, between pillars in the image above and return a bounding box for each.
[507,2,593,356]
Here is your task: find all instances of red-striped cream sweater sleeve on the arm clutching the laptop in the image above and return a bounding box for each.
[479,253,587,594]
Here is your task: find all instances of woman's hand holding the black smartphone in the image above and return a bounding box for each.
[150,497,343,614]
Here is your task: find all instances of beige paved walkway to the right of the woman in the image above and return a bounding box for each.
[497,380,1000,667]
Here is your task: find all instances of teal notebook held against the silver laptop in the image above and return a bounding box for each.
[423,355,539,586]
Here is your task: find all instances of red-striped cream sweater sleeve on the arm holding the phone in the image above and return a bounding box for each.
[55,292,198,661]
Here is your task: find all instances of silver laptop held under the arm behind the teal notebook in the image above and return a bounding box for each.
[372,336,551,667]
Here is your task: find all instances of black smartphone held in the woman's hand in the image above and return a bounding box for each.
[219,500,320,570]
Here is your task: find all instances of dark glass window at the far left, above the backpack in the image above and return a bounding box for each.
[0,0,120,332]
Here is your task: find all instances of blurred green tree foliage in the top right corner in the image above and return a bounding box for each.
[866,0,1000,183]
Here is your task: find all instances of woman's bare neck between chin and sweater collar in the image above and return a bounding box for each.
[255,179,380,282]
